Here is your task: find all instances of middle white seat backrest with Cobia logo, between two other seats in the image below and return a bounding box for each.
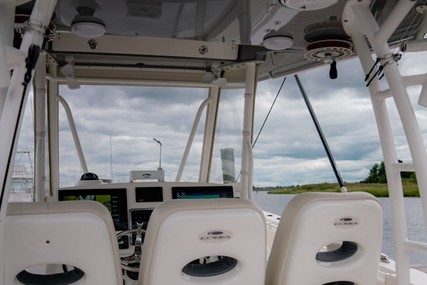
[139,199,266,285]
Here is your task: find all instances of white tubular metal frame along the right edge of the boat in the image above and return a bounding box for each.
[343,0,427,284]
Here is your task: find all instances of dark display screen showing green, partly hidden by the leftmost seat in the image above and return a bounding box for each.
[58,189,128,231]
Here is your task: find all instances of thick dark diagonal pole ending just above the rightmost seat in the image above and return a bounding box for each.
[294,74,347,193]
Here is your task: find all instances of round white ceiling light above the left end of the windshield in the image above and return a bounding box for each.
[71,7,106,39]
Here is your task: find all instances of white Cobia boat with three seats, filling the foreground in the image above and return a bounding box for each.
[0,0,427,285]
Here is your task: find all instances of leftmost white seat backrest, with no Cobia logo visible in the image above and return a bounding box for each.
[2,201,123,285]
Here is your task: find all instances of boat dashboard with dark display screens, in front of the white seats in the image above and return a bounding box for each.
[57,181,240,246]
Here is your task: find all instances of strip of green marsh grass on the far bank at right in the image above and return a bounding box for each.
[268,183,420,197]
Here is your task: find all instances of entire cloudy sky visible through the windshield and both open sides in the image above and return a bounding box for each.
[18,51,427,187]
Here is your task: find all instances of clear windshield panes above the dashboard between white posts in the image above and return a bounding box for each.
[59,86,243,187]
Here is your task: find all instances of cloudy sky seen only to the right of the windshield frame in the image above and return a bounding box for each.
[254,53,427,186]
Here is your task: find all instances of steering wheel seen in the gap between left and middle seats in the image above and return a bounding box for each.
[117,223,145,273]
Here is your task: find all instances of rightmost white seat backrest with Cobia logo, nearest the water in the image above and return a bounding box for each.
[265,192,383,285]
